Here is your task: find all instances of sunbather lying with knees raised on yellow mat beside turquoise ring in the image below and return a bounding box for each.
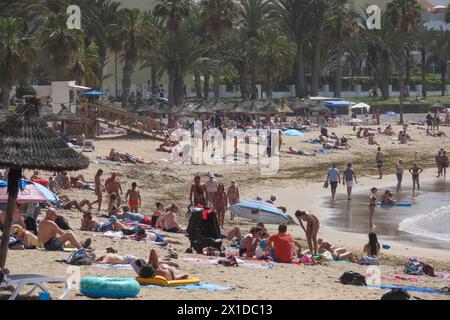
[131,249,189,281]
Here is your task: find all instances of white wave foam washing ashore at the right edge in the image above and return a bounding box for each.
[398,206,450,242]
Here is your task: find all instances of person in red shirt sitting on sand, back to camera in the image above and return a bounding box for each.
[267,224,295,263]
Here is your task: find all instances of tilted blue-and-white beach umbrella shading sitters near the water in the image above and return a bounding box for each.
[230,200,290,224]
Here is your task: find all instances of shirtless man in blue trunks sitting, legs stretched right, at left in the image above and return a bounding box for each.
[38,208,93,251]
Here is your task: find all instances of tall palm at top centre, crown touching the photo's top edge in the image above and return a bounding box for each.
[200,0,237,99]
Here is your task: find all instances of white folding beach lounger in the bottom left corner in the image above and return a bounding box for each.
[0,270,70,300]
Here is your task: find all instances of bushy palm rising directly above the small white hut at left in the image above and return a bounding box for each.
[40,13,84,81]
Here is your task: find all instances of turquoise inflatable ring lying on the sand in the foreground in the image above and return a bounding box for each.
[80,277,141,299]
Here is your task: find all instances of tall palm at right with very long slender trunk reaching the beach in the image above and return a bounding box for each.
[387,0,422,123]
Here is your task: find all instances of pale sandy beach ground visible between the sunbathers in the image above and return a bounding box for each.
[2,120,450,300]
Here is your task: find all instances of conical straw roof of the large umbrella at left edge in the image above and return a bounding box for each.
[0,105,89,171]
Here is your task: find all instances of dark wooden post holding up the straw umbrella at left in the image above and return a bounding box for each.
[0,169,22,269]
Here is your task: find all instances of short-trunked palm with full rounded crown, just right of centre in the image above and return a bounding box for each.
[256,28,295,100]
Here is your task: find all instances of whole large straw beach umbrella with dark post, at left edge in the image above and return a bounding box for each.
[0,98,89,268]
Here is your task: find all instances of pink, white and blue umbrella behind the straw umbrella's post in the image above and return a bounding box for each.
[0,179,60,207]
